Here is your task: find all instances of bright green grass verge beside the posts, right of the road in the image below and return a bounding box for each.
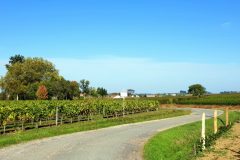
[144,112,240,160]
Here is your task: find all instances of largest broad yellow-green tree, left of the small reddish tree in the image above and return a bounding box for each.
[4,58,59,100]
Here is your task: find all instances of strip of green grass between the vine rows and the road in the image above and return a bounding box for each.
[0,109,191,148]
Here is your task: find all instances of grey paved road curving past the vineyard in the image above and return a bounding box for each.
[0,109,221,160]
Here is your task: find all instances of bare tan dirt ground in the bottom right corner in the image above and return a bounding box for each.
[198,123,240,160]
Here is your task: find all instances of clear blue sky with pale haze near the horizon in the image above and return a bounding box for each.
[0,0,240,92]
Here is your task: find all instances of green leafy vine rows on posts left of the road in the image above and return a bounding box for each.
[0,99,159,134]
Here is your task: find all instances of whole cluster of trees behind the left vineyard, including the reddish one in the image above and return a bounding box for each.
[0,55,107,100]
